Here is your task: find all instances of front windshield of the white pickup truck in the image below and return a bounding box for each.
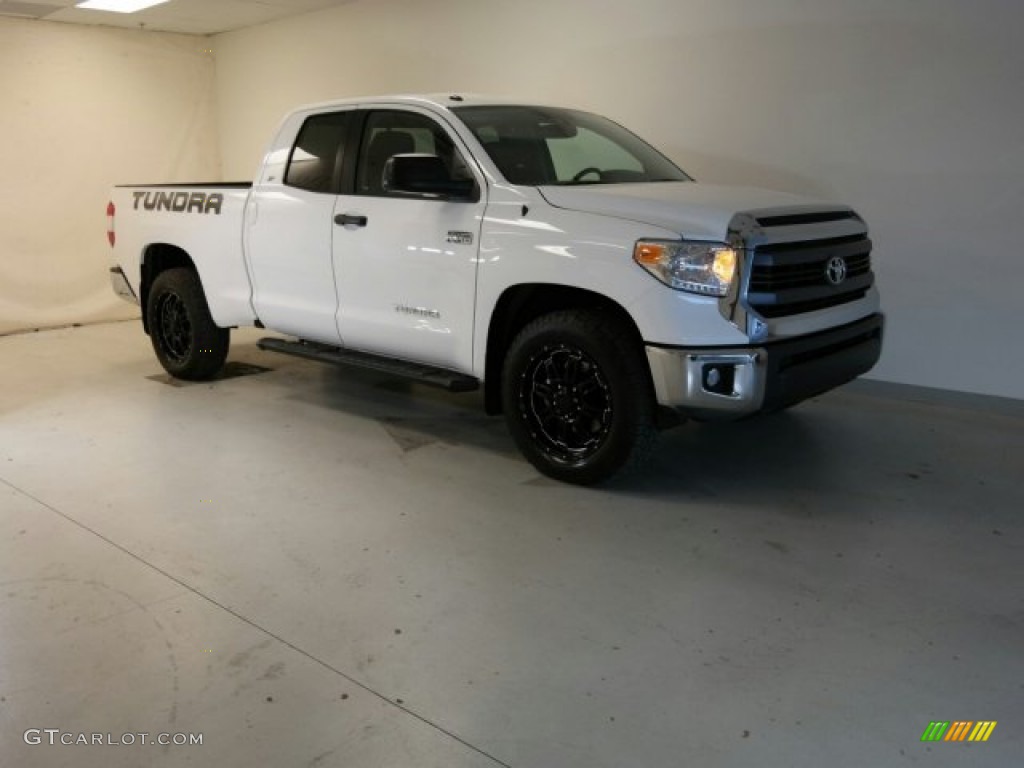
[452,106,691,186]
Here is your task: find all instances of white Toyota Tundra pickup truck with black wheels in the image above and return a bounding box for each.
[106,95,883,483]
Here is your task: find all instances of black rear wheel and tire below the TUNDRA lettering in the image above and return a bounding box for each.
[146,268,230,381]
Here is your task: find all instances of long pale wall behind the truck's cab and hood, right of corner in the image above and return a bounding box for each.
[215,0,1024,397]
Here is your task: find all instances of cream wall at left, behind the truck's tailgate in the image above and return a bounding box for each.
[0,18,220,333]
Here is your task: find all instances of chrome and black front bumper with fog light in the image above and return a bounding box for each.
[646,313,884,419]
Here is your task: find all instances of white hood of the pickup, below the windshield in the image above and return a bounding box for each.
[540,181,821,241]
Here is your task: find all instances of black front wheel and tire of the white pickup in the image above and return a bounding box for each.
[502,310,656,485]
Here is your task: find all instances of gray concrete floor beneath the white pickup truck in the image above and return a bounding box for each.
[0,323,1024,768]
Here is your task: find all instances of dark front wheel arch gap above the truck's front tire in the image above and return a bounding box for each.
[483,283,653,415]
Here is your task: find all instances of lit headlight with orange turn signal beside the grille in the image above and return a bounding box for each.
[633,240,737,296]
